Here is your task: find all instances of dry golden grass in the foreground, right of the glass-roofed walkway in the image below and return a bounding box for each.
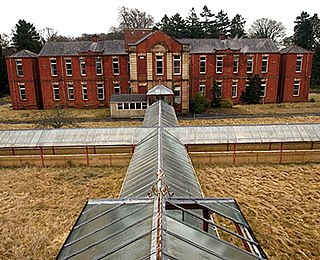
[196,164,320,260]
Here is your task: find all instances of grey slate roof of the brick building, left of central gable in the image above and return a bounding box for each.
[39,40,126,56]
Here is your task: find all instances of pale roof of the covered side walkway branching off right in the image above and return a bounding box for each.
[166,124,320,144]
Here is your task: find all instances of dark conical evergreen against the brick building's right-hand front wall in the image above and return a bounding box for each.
[240,74,262,104]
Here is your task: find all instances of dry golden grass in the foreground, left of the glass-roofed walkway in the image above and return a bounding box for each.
[0,167,126,259]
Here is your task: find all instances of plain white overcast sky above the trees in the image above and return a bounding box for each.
[0,0,320,36]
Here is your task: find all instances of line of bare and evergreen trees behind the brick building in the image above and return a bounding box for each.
[0,6,320,95]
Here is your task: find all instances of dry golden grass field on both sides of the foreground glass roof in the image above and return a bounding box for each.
[0,164,320,260]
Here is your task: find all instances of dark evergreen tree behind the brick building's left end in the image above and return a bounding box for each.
[12,20,43,53]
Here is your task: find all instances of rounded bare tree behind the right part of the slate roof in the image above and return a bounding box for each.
[248,18,286,43]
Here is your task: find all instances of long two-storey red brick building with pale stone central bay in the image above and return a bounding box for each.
[6,29,312,112]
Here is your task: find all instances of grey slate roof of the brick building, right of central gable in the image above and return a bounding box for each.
[179,38,279,54]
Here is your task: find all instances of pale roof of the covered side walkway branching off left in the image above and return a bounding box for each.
[0,127,153,148]
